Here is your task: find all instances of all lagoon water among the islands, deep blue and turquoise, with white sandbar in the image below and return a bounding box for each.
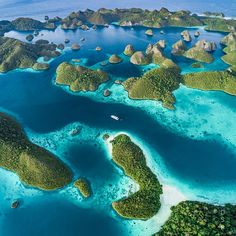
[0,14,236,236]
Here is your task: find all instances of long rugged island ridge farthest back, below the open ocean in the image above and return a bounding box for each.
[61,7,236,32]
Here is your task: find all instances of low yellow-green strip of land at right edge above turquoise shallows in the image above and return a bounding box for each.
[182,71,236,96]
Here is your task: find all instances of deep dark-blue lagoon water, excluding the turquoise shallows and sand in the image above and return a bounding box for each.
[0,23,236,236]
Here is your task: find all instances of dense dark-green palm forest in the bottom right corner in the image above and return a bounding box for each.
[155,201,236,236]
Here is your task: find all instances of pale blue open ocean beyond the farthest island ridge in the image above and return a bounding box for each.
[0,0,236,19]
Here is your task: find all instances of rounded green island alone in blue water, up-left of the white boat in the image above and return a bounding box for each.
[56,62,109,92]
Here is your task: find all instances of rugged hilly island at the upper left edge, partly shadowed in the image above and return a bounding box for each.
[0,37,60,72]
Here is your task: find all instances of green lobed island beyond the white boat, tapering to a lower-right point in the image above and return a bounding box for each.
[123,66,181,109]
